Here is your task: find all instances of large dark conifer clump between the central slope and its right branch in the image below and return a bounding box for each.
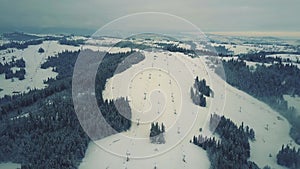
[190,114,259,169]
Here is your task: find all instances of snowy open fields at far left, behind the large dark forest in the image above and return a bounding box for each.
[0,38,131,97]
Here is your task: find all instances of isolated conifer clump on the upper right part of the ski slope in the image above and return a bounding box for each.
[190,76,212,107]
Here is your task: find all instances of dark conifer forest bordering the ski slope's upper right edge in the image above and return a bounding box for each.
[216,59,300,144]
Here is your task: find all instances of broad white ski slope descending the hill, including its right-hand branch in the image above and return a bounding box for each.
[79,52,299,169]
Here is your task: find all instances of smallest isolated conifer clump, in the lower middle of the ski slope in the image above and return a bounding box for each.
[150,122,166,144]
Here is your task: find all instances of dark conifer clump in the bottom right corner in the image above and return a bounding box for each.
[277,145,300,169]
